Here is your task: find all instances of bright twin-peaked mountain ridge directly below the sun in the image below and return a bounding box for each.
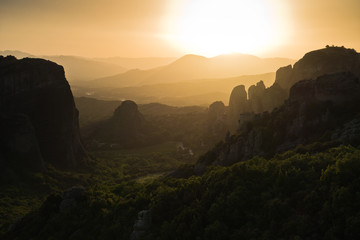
[86,54,295,88]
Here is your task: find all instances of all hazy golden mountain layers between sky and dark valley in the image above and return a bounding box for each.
[0,51,295,106]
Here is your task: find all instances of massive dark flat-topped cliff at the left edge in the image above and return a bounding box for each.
[0,57,86,168]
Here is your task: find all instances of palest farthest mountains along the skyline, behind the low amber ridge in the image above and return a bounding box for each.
[0,50,295,87]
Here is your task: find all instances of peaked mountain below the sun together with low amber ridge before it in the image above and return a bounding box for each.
[72,54,294,106]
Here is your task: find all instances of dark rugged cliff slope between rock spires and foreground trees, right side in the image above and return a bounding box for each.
[195,72,360,172]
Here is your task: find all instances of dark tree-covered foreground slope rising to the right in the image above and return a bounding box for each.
[5,143,360,239]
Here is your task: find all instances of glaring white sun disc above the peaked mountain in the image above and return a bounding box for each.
[167,0,281,57]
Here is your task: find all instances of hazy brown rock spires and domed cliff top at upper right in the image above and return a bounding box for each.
[229,47,360,130]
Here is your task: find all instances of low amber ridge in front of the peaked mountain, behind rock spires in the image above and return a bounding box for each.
[72,70,275,106]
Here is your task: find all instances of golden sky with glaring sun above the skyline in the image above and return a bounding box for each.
[0,0,360,59]
